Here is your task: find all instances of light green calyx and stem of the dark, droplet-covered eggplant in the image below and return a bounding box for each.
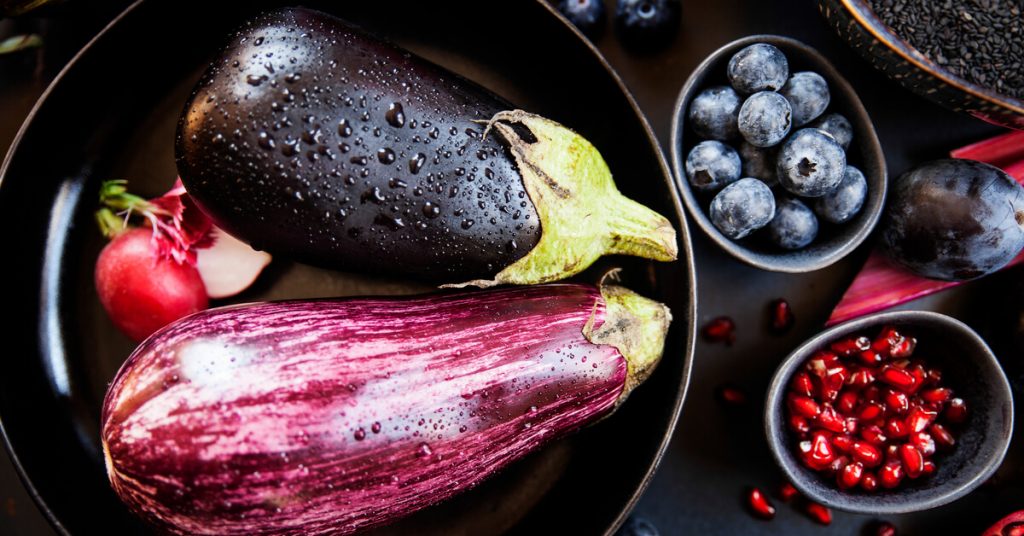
[445,110,678,287]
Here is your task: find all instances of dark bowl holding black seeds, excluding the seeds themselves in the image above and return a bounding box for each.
[818,0,1024,130]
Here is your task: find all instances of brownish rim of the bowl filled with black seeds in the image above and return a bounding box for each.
[839,0,1024,116]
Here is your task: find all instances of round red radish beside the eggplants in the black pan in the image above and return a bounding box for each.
[95,229,208,341]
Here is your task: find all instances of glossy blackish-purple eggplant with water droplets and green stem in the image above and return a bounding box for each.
[176,8,677,286]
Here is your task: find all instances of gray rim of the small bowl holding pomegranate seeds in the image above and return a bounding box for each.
[764,310,1014,514]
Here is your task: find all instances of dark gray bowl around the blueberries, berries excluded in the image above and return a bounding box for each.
[671,35,888,273]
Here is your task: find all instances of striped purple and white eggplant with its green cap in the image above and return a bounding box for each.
[102,284,671,535]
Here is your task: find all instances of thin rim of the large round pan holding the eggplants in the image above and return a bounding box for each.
[0,0,698,536]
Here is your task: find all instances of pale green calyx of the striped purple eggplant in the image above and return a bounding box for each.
[583,285,672,406]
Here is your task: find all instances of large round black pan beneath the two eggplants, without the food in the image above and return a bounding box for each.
[0,0,695,535]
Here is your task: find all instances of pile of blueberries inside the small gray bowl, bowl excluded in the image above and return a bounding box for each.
[685,43,867,250]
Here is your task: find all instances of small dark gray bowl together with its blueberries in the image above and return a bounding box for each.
[672,35,887,273]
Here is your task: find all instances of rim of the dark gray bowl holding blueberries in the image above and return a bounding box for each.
[669,34,889,274]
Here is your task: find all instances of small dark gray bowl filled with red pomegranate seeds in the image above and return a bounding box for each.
[765,311,1014,514]
